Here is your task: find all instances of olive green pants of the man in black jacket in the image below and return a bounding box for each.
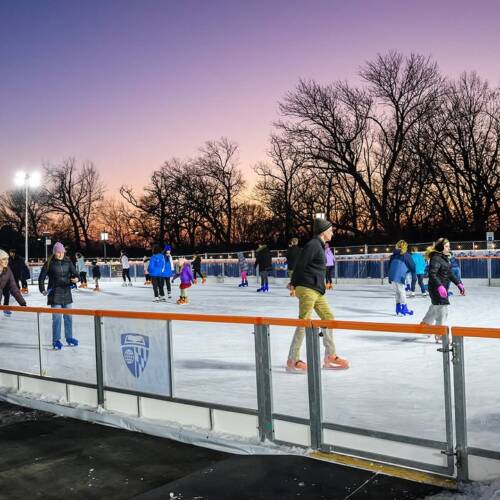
[288,286,336,361]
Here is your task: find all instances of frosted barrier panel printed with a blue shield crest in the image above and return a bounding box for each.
[102,318,170,396]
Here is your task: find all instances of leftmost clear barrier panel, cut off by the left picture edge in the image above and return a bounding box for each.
[0,311,41,375]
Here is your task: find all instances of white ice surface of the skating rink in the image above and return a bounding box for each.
[0,279,500,451]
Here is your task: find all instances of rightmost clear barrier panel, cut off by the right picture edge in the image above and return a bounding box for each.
[462,336,500,452]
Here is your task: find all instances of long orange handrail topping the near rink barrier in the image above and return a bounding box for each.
[0,306,490,338]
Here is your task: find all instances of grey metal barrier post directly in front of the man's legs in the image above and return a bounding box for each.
[306,327,323,450]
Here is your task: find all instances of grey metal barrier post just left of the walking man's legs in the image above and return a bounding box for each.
[255,325,274,441]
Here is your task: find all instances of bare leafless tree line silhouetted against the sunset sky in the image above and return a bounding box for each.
[0,52,500,256]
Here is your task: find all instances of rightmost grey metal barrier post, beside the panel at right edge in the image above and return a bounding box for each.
[451,328,469,481]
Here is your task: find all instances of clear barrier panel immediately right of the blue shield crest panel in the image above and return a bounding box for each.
[172,321,257,410]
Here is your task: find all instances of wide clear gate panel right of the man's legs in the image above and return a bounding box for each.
[321,330,446,441]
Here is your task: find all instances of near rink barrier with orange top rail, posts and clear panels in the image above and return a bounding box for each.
[0,307,500,479]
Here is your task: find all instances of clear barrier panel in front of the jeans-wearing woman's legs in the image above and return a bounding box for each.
[38,313,96,384]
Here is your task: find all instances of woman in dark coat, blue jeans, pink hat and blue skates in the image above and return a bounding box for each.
[38,242,78,350]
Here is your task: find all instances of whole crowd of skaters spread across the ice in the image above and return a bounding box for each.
[0,219,465,360]
